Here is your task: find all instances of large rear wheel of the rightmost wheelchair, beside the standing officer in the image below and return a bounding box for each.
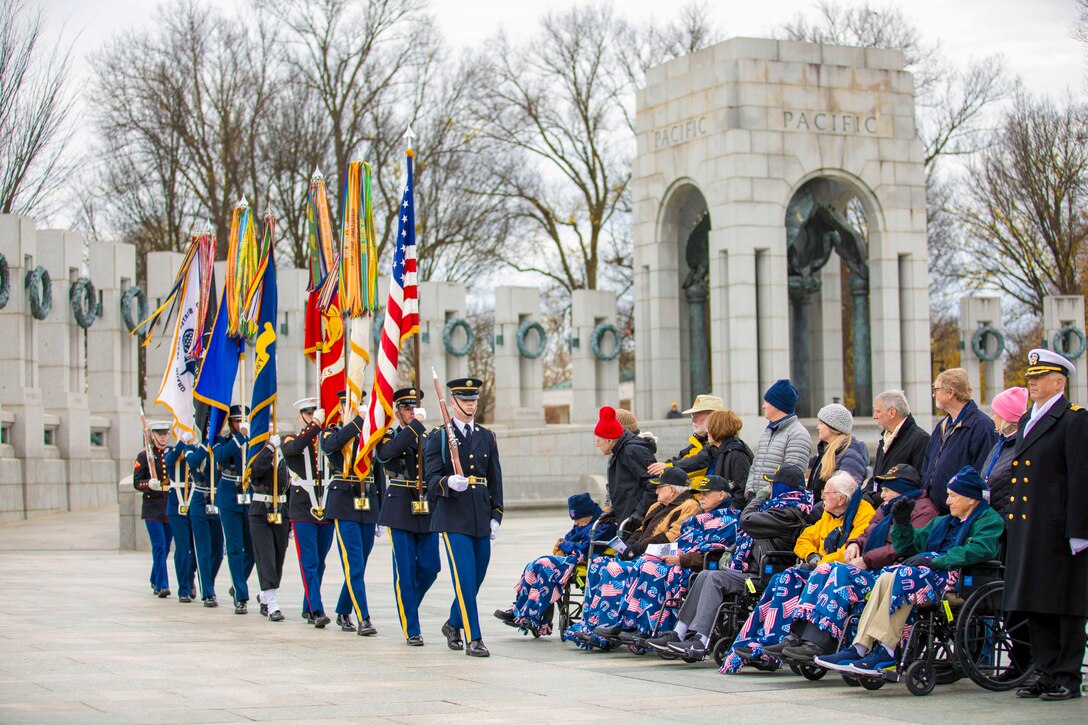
[955,581,1033,692]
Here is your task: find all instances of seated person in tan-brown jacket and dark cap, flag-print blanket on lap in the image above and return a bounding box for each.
[564,468,702,647]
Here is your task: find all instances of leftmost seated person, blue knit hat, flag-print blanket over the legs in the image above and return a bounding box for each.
[495,493,616,637]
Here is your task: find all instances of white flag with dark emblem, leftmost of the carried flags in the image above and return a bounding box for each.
[154,253,200,435]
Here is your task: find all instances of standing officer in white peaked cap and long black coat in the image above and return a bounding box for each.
[1004,349,1088,700]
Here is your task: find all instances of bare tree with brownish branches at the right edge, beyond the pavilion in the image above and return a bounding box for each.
[957,93,1088,315]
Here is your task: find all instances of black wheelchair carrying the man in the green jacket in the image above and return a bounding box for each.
[842,561,1033,696]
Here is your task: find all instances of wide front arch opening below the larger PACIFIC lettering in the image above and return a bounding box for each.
[783,169,883,416]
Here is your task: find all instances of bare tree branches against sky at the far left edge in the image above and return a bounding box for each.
[0,0,74,214]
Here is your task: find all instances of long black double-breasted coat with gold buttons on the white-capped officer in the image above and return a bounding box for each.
[1004,397,1088,617]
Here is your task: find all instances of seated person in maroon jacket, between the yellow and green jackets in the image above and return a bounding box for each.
[733,464,937,666]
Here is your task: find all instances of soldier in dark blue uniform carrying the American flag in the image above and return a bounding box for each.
[374,388,442,647]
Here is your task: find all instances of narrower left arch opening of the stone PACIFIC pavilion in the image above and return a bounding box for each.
[657,177,714,407]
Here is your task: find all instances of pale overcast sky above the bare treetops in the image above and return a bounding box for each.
[53,0,1085,95]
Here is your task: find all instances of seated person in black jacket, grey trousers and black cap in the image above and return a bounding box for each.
[647,464,813,662]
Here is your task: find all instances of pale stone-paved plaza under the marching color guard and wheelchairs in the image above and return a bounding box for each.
[0,506,1088,723]
